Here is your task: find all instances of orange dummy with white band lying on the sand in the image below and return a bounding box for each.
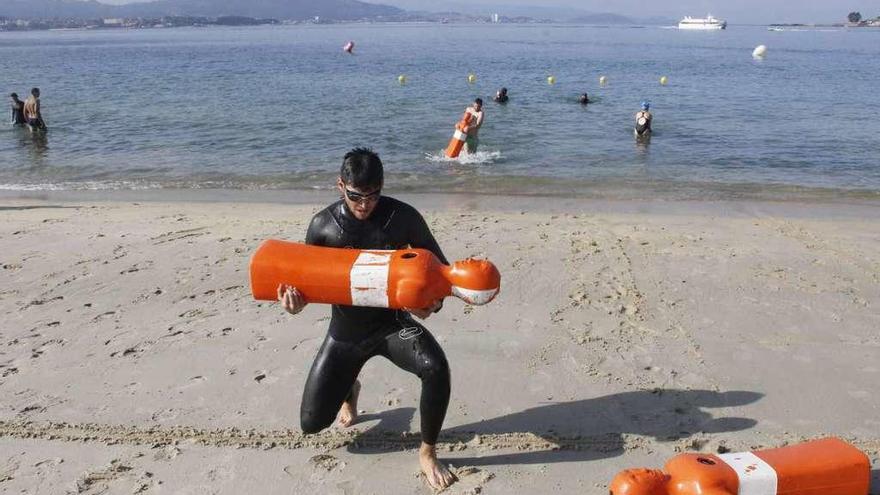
[610,438,871,495]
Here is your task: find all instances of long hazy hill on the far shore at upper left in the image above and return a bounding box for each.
[0,0,404,20]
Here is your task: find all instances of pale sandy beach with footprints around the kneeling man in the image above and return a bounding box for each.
[0,192,880,494]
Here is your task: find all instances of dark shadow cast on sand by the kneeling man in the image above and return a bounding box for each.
[348,389,763,466]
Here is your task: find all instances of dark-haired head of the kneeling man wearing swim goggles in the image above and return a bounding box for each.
[336,148,384,220]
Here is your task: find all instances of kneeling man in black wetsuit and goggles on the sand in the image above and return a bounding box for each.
[278,148,455,489]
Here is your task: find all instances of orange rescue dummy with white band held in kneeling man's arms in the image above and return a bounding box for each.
[251,239,501,309]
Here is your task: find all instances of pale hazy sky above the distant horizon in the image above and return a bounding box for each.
[91,0,880,24]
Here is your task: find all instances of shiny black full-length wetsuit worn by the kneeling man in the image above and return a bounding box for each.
[300,196,450,445]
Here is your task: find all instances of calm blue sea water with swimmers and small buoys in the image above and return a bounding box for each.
[0,25,880,197]
